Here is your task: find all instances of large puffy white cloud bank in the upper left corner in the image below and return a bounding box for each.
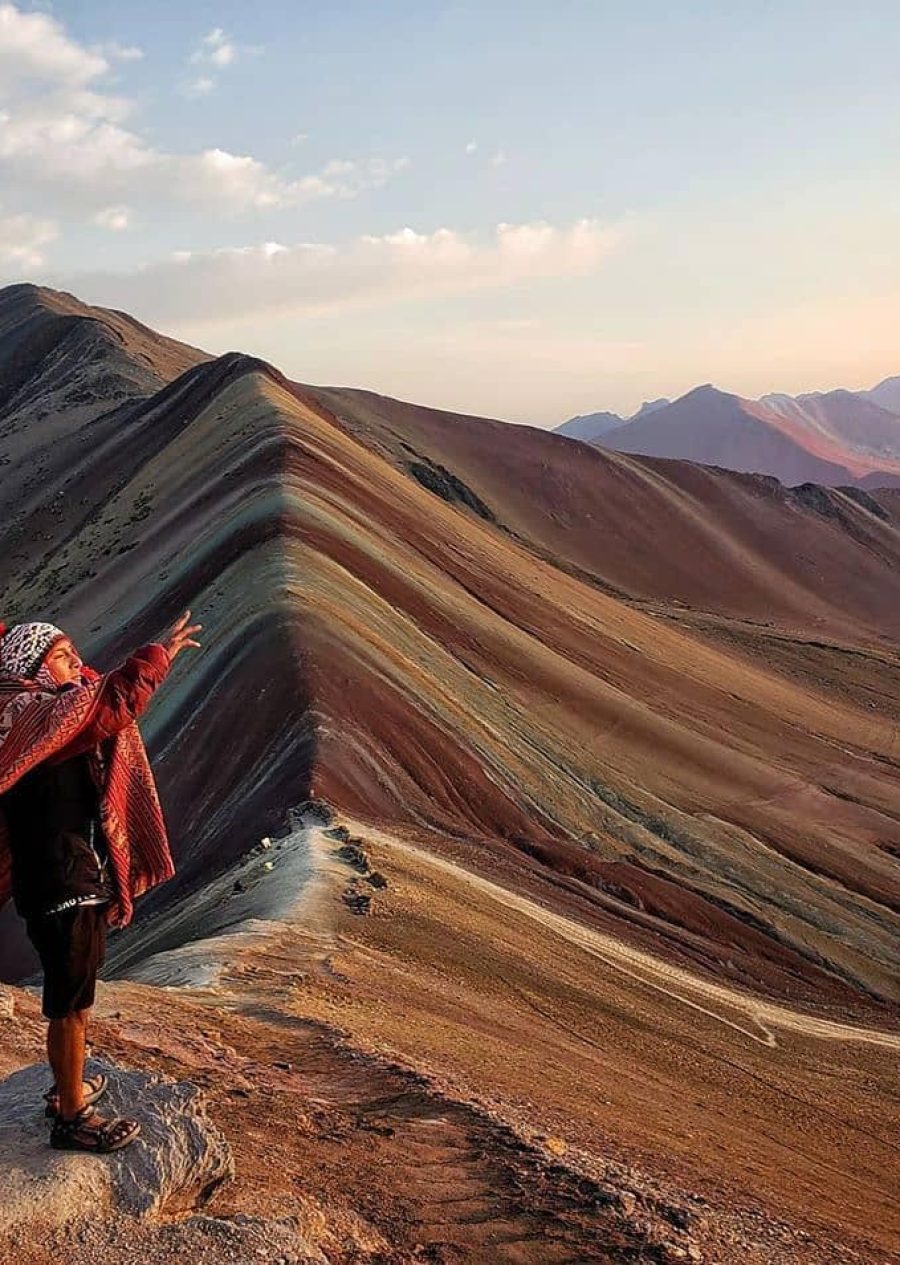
[0,3,403,215]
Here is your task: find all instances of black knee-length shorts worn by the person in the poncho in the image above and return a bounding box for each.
[25,904,108,1020]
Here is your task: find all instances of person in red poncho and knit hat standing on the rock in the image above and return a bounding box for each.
[0,610,203,1151]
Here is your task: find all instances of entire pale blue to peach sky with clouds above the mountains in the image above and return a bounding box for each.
[0,0,900,425]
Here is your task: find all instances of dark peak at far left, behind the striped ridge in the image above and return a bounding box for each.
[0,285,209,602]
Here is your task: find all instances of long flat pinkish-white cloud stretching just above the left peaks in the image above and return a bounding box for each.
[70,220,622,324]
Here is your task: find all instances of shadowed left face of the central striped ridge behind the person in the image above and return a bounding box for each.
[0,346,320,966]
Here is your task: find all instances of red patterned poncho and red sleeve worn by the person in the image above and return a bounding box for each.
[0,641,175,927]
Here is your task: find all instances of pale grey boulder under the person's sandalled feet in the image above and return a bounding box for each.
[0,1059,234,1235]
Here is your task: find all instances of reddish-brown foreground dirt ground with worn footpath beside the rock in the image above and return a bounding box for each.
[0,984,677,1265]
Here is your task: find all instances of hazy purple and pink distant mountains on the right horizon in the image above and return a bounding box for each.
[556,377,900,488]
